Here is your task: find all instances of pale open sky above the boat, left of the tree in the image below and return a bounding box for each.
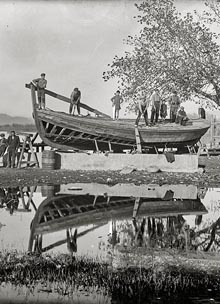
[0,0,217,117]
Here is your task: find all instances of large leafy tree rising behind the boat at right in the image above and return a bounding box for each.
[103,0,220,110]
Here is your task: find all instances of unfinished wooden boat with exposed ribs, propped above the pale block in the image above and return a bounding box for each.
[26,84,210,152]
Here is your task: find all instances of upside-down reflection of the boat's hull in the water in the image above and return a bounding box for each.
[32,185,207,234]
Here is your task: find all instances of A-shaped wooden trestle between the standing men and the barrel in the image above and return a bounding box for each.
[18,134,39,169]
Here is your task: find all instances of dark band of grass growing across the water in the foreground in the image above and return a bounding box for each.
[0,251,220,303]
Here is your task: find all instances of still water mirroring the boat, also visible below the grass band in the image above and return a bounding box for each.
[0,183,220,303]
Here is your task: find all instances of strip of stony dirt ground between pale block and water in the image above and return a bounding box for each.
[0,156,220,187]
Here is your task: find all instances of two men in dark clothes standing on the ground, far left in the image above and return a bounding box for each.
[0,131,20,168]
